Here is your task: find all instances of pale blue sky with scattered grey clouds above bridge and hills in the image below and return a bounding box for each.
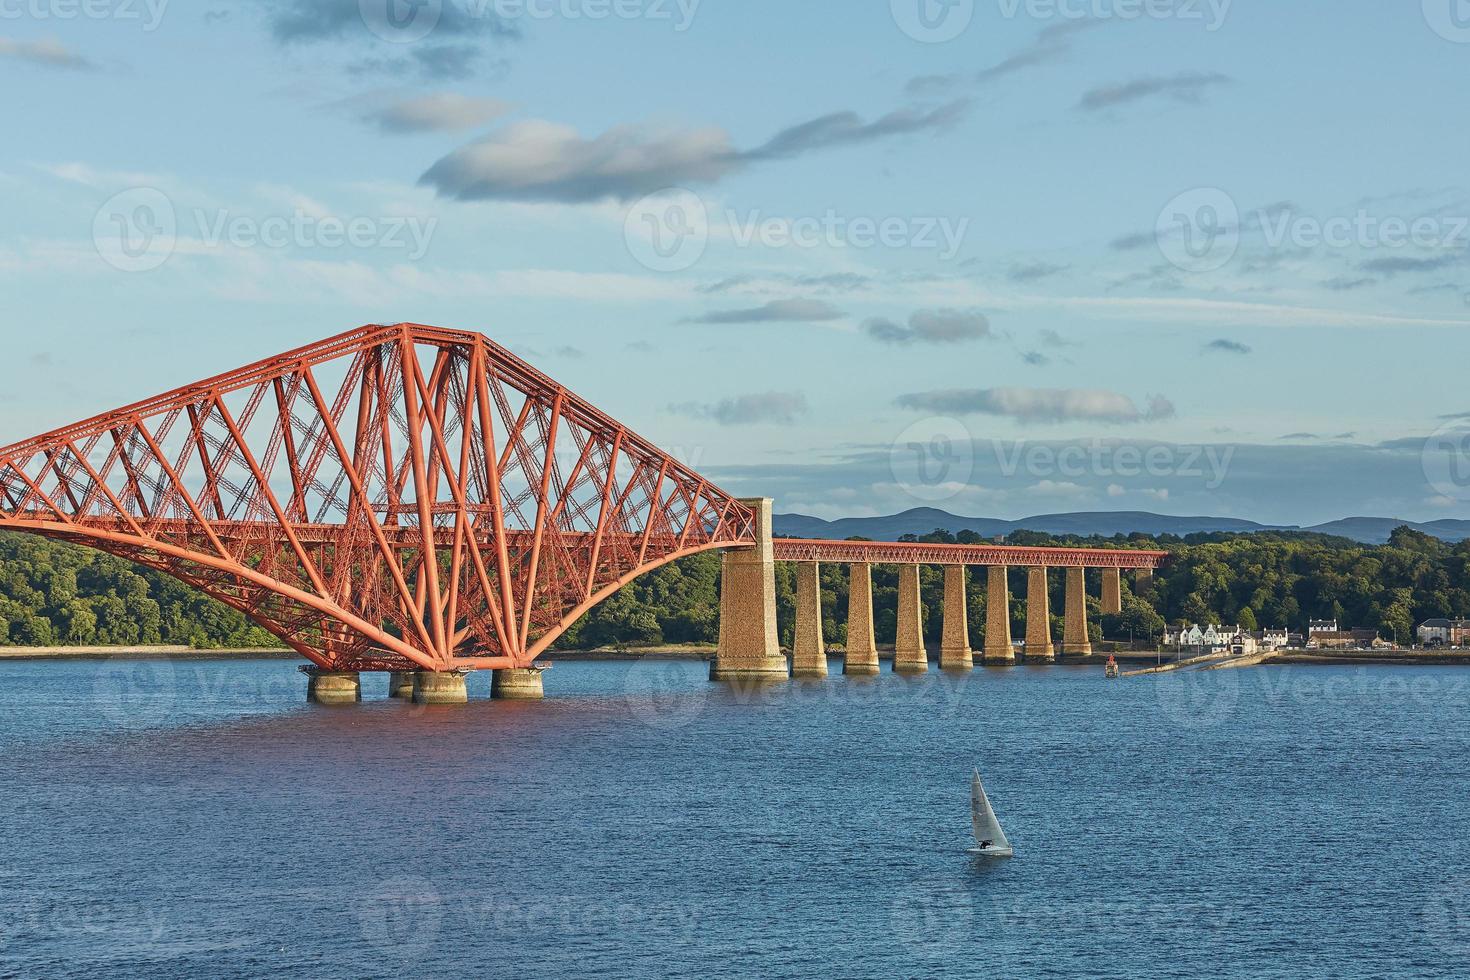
[0,0,1470,525]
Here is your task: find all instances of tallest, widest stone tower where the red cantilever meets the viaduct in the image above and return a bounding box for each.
[710,497,791,680]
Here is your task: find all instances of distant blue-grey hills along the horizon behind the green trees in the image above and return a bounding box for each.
[775,507,1470,545]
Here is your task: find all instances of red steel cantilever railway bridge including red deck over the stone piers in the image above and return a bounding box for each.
[0,323,1163,671]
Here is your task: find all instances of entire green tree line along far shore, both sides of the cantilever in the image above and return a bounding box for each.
[0,527,1470,649]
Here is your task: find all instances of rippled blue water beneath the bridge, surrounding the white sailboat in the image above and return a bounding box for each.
[0,661,1470,977]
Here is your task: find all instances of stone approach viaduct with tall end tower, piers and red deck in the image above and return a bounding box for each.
[710,498,1167,680]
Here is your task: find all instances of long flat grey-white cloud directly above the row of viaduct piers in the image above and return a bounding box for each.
[898,388,1175,425]
